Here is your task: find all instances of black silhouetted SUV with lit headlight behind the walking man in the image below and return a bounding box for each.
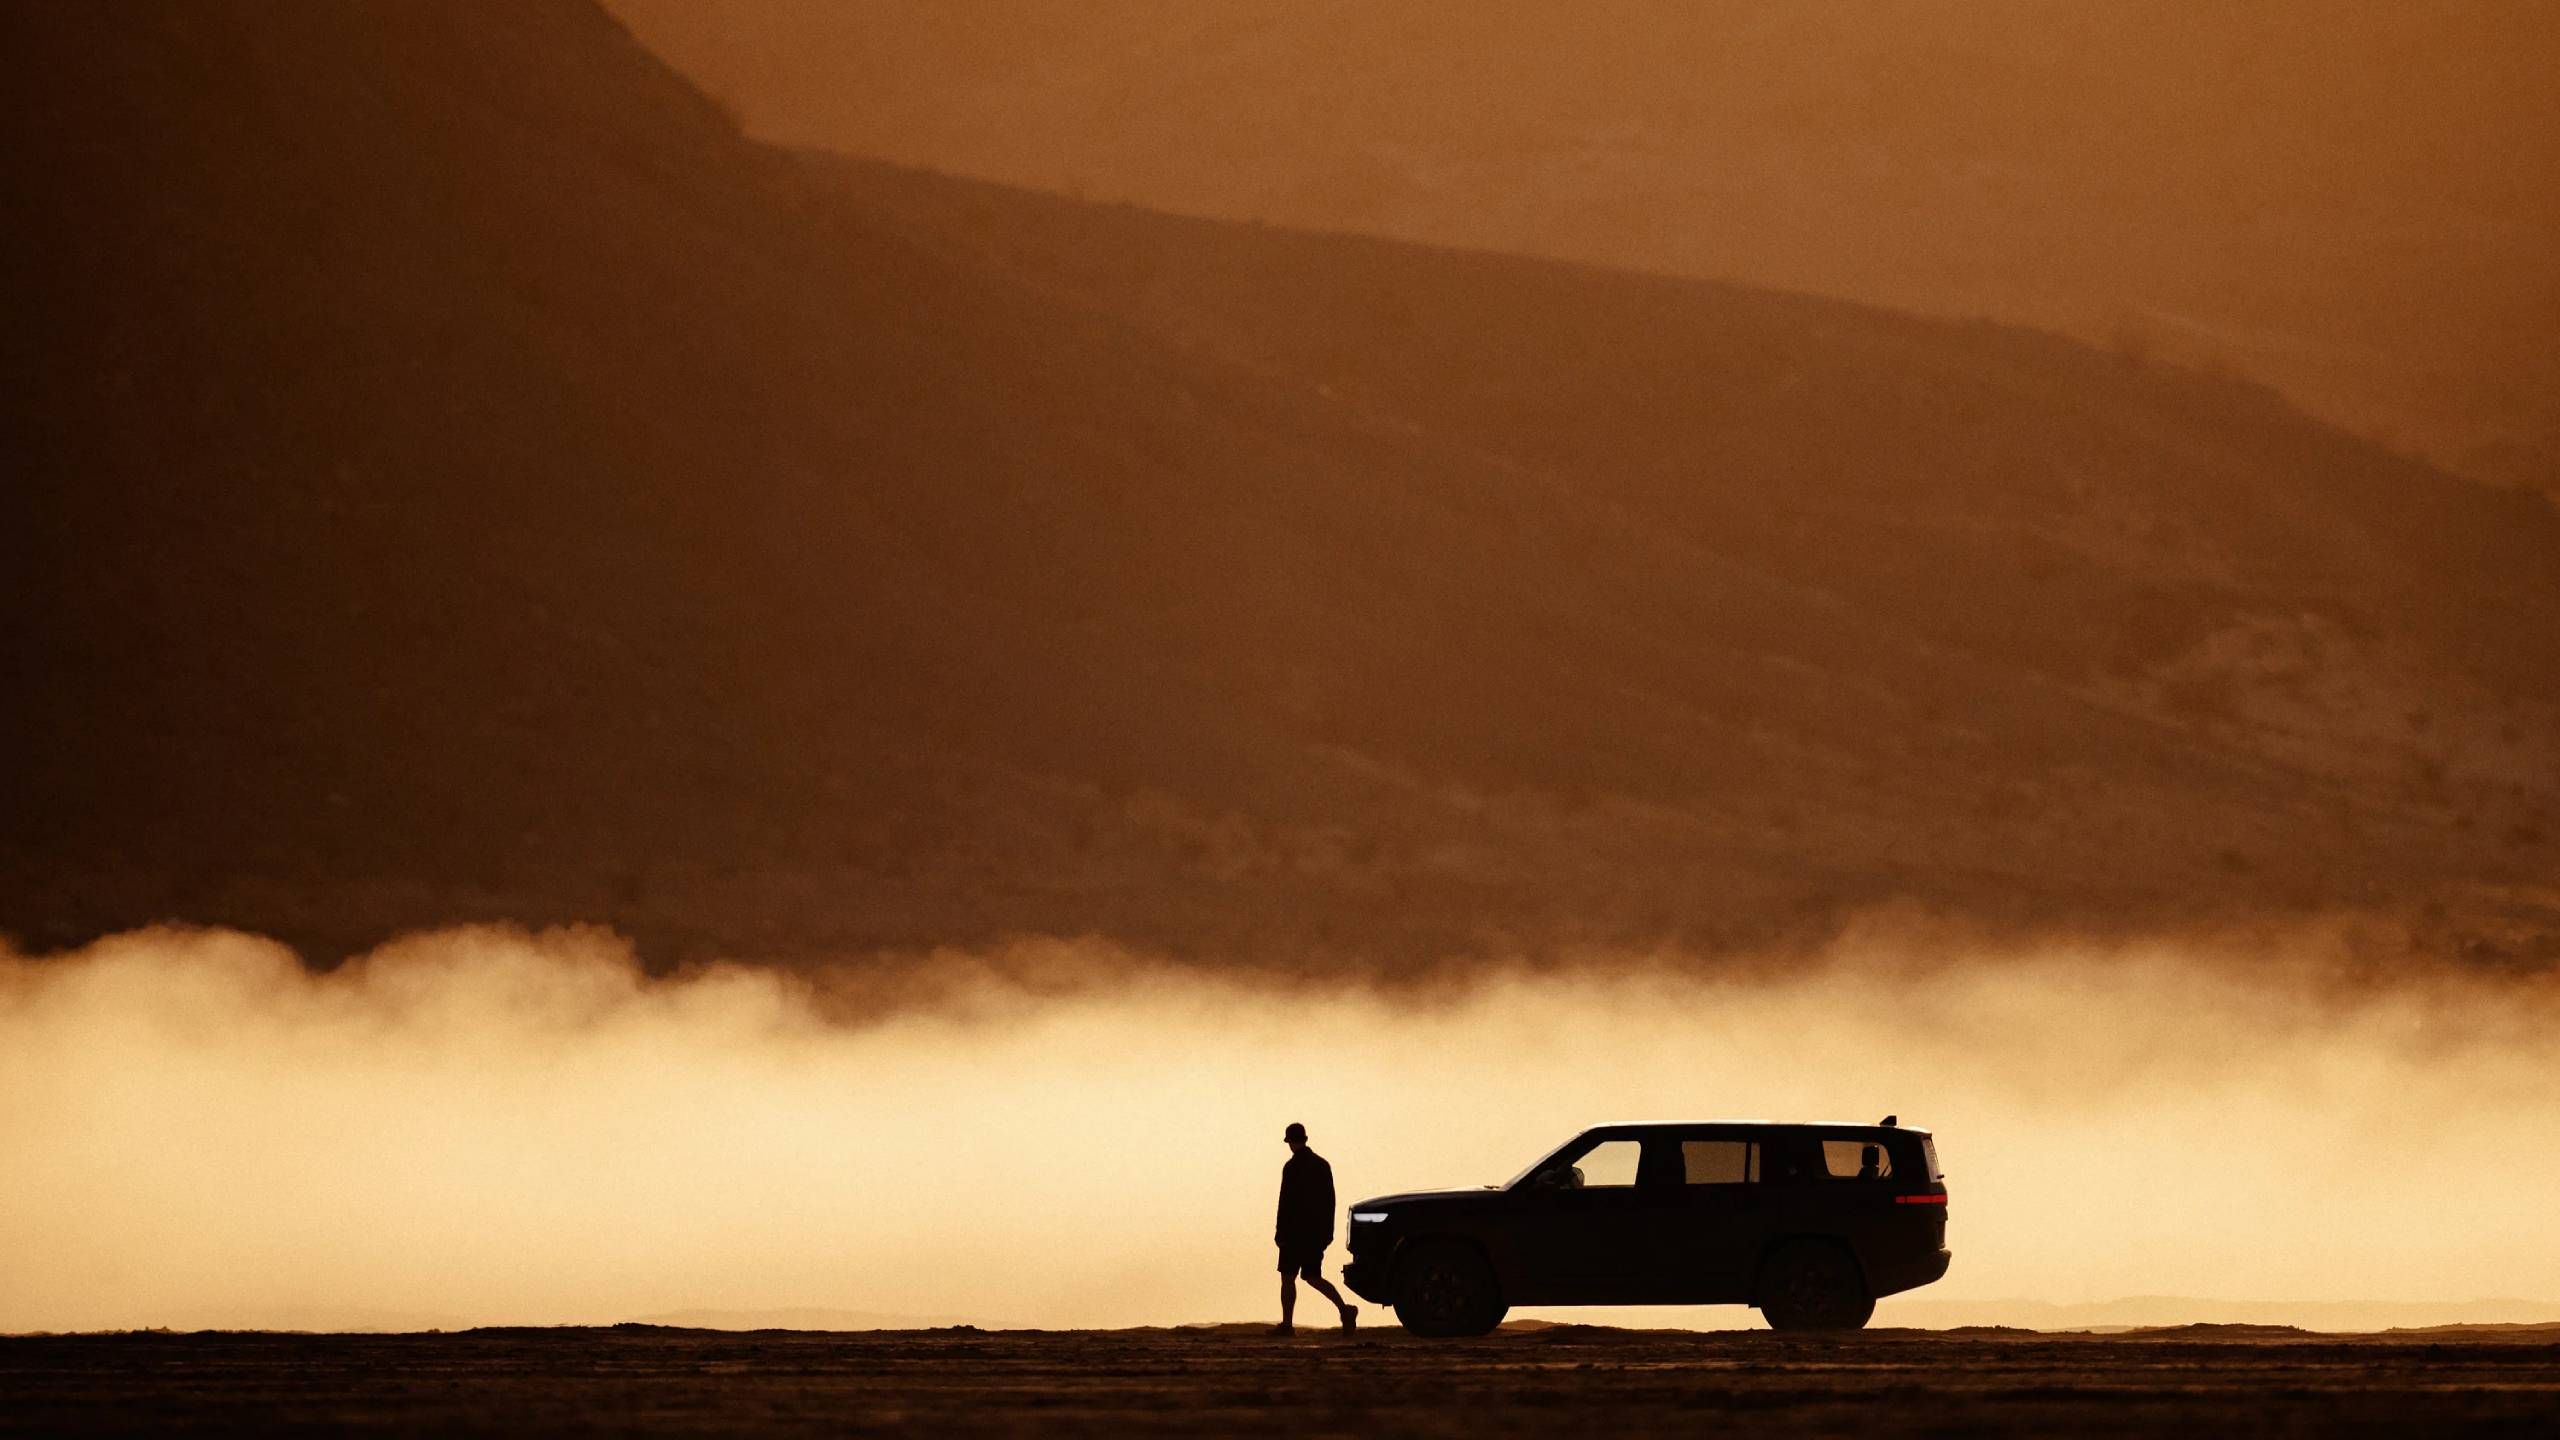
[1341,1115,1948,1335]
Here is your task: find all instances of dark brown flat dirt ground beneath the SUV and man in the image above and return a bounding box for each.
[0,1325,2560,1435]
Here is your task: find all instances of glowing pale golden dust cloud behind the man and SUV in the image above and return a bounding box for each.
[0,928,2560,1330]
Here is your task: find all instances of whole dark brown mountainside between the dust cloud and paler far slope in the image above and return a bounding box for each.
[0,0,2560,956]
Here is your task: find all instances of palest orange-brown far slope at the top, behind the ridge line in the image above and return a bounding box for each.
[612,0,2560,487]
